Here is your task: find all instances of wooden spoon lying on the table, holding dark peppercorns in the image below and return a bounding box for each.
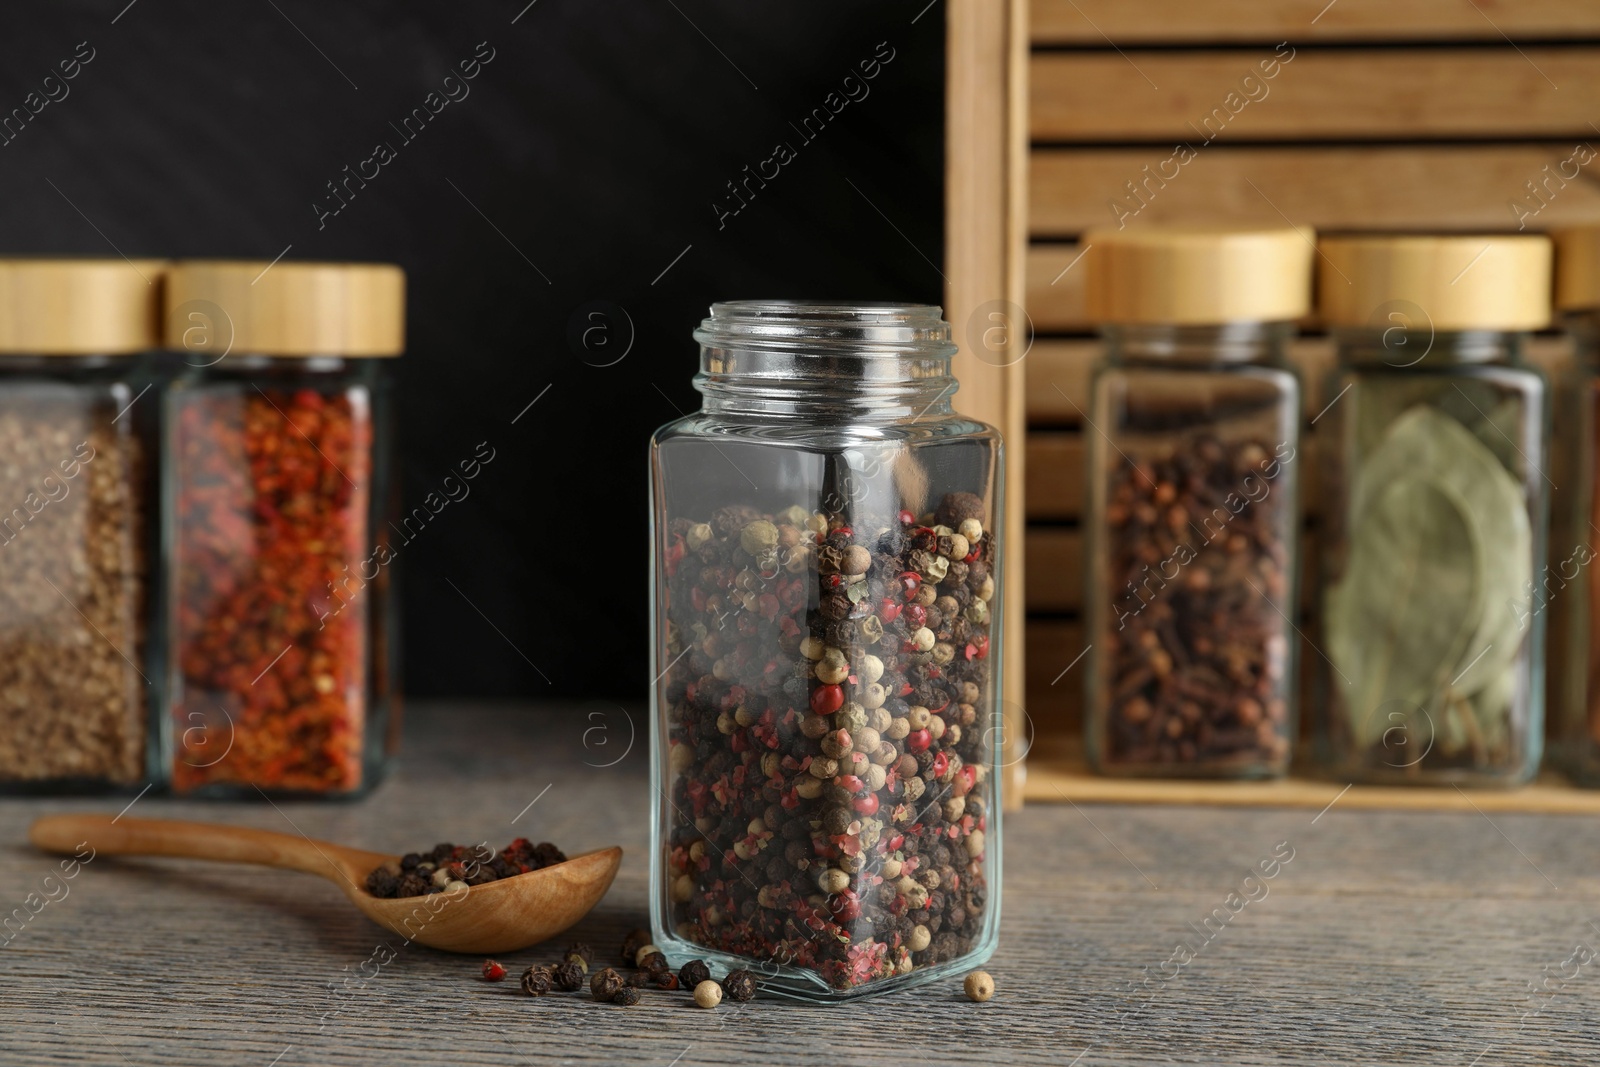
[29,816,622,953]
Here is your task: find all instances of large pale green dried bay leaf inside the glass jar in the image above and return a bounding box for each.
[1325,476,1483,745]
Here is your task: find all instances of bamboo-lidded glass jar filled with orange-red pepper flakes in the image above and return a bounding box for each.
[163,261,405,797]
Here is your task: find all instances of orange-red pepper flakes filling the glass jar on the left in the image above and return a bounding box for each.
[171,387,373,792]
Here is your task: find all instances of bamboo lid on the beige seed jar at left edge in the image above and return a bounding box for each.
[0,259,166,355]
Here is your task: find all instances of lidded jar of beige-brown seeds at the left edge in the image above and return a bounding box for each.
[0,259,165,790]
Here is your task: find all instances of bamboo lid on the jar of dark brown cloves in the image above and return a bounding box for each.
[1083,226,1312,326]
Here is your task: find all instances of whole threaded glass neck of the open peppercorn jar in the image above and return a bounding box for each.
[694,301,957,422]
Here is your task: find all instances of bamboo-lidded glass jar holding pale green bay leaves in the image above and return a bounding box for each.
[1315,235,1550,785]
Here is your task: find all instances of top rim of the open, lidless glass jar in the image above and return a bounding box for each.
[694,299,957,358]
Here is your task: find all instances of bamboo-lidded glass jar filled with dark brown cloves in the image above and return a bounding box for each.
[1061,227,1312,777]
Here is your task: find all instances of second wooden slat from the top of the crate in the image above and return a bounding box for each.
[1029,48,1600,147]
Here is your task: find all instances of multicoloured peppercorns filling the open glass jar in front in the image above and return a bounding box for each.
[661,493,995,998]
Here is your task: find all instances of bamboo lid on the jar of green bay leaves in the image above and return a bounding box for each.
[1317,234,1550,330]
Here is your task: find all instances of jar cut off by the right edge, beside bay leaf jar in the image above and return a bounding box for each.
[1534,226,1600,785]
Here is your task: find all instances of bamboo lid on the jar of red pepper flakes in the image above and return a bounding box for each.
[165,259,405,357]
